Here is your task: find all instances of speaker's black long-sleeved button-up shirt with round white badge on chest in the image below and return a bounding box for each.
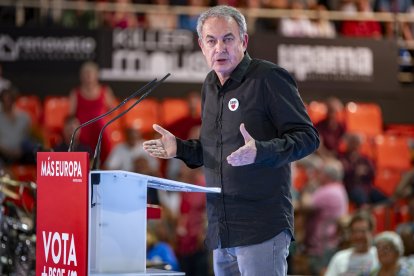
[177,53,319,249]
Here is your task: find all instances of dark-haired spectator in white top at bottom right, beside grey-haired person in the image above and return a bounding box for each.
[325,212,379,276]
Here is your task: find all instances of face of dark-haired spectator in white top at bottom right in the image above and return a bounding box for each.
[350,220,372,253]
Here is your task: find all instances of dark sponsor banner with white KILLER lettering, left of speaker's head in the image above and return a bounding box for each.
[100,29,209,83]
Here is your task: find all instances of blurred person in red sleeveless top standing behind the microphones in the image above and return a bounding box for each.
[69,62,115,161]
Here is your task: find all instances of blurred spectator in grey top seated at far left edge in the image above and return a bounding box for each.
[0,88,35,164]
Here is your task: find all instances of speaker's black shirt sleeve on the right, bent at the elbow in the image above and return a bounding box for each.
[255,68,319,167]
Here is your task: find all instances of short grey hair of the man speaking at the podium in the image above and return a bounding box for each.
[197,5,247,39]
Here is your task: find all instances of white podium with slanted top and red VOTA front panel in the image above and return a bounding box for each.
[36,152,220,276]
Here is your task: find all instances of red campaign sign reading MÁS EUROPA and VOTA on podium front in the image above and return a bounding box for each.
[36,152,89,276]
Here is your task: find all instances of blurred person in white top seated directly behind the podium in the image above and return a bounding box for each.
[105,128,158,171]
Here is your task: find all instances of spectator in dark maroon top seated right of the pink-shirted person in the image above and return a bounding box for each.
[339,133,387,207]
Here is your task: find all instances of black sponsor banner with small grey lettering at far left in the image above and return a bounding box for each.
[0,28,98,71]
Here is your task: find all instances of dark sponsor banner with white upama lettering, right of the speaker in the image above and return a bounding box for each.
[250,34,399,93]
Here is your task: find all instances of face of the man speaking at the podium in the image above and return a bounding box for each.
[198,17,248,83]
